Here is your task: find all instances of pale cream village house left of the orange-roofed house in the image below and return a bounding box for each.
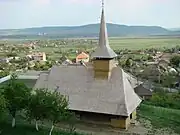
[27,52,46,61]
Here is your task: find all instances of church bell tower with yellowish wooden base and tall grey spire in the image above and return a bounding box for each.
[91,1,117,79]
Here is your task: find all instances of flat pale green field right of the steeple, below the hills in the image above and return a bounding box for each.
[109,37,180,50]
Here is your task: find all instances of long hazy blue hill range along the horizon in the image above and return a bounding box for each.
[0,23,179,38]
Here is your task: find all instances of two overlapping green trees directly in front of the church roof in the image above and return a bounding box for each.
[27,89,74,134]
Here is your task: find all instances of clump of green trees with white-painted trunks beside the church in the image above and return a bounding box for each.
[0,74,76,135]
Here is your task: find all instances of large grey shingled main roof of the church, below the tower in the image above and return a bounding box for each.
[35,65,141,116]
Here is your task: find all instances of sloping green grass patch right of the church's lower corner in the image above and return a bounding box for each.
[139,104,180,134]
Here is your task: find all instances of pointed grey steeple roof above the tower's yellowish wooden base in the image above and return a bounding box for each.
[92,0,117,58]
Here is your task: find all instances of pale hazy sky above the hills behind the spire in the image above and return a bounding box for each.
[0,0,180,29]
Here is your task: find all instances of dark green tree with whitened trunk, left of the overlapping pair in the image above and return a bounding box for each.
[3,74,30,127]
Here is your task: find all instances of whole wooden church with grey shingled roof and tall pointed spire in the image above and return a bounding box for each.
[34,3,141,129]
